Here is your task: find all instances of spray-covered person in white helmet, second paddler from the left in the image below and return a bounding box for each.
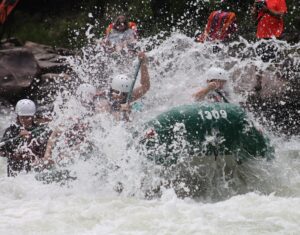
[41,83,97,165]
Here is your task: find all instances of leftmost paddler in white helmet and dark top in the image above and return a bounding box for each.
[0,99,54,176]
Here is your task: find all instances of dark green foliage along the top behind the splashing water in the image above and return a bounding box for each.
[1,0,300,48]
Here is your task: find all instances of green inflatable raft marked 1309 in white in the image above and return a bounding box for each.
[143,103,274,165]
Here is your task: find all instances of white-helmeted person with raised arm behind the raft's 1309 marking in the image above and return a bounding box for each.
[193,67,229,103]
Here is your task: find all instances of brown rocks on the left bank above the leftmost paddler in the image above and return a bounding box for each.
[0,39,72,103]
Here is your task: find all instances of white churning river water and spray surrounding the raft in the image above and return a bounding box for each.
[0,34,300,235]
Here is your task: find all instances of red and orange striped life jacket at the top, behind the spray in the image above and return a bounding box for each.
[196,11,236,42]
